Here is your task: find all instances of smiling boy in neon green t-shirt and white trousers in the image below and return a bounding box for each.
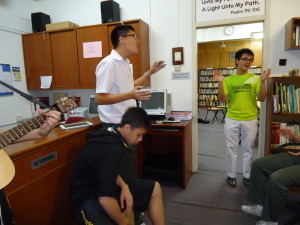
[214,48,271,187]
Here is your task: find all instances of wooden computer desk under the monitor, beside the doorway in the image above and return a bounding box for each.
[137,120,192,188]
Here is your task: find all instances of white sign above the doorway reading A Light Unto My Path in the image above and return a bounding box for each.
[196,0,266,22]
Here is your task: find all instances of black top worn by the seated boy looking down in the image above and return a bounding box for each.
[70,130,128,211]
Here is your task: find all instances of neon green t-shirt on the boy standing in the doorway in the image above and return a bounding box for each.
[223,73,260,121]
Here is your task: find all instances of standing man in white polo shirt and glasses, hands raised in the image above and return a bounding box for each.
[96,25,166,126]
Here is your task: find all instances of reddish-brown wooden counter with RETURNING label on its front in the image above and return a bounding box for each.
[4,117,101,225]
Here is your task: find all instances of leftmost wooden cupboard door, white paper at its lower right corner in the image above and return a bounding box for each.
[22,33,53,90]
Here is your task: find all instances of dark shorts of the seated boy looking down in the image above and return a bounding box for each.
[75,179,155,225]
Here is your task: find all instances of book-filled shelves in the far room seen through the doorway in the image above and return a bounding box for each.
[198,66,261,108]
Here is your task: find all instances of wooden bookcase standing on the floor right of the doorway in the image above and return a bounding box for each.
[265,76,300,155]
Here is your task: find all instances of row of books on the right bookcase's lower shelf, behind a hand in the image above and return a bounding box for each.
[271,122,300,147]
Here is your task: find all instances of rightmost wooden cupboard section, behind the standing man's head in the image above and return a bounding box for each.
[108,20,150,80]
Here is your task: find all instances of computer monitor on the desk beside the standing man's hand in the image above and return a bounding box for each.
[139,89,170,116]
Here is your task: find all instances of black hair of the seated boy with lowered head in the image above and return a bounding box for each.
[120,107,151,129]
